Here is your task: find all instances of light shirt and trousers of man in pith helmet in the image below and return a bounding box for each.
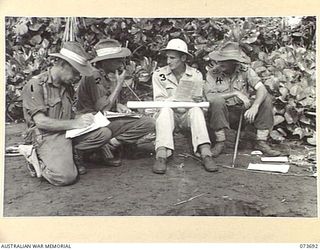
[152,65,210,154]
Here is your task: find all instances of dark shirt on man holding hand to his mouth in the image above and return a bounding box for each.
[76,69,116,113]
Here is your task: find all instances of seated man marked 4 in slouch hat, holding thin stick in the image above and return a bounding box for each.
[205,42,280,157]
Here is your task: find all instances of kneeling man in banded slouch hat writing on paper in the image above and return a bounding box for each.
[22,42,111,186]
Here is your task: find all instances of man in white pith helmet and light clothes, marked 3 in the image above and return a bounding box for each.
[152,39,218,174]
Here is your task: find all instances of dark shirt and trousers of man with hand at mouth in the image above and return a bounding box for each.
[76,69,154,144]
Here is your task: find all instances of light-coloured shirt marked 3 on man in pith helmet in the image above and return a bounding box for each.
[152,65,203,101]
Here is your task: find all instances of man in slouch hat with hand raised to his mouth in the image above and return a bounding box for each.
[76,39,155,165]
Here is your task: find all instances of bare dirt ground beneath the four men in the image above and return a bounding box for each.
[3,123,317,217]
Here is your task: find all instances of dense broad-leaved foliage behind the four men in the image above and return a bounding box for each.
[6,17,316,144]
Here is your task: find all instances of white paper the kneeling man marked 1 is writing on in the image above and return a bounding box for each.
[66,112,110,138]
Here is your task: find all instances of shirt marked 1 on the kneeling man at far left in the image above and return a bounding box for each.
[22,70,74,135]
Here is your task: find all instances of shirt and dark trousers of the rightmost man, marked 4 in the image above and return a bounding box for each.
[204,63,273,135]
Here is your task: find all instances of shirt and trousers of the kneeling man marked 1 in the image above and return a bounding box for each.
[22,70,110,186]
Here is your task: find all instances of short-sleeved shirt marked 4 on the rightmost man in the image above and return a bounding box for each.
[204,64,261,105]
